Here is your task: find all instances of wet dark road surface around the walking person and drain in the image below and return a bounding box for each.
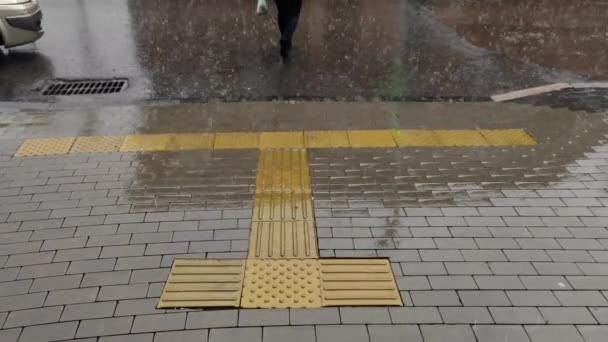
[0,0,608,103]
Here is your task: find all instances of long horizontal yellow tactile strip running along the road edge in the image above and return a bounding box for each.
[15,129,536,157]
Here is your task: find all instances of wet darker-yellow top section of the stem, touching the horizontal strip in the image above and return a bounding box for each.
[256,149,311,194]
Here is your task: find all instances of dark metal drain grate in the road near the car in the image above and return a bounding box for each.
[42,78,127,96]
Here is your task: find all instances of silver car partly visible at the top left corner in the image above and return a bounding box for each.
[0,0,44,48]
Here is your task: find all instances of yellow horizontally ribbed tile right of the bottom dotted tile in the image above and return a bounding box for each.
[319,259,403,306]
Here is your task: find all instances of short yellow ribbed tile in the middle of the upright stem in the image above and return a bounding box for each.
[252,193,314,221]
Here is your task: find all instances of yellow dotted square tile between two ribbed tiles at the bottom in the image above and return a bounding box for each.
[241,259,321,308]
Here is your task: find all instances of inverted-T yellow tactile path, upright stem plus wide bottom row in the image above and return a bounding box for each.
[158,148,403,308]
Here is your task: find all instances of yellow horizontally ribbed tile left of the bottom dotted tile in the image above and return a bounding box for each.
[157,259,245,309]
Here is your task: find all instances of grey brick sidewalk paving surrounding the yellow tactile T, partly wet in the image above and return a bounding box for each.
[0,102,608,342]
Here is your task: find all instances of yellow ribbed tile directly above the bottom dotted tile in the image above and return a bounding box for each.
[248,220,318,259]
